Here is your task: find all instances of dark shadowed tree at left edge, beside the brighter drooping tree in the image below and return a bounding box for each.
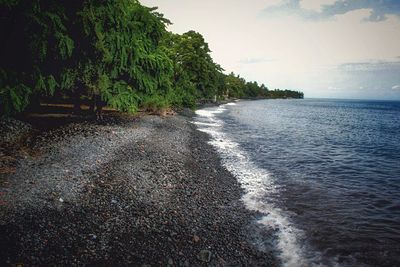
[0,0,74,114]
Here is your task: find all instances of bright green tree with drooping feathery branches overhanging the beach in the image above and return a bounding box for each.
[78,0,172,112]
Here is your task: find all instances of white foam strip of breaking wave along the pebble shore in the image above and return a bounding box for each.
[195,107,312,267]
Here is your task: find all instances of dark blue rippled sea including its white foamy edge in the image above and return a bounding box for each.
[194,99,400,266]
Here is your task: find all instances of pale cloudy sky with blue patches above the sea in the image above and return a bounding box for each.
[141,0,400,100]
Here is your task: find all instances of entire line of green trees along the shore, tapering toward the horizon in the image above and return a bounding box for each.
[0,0,303,115]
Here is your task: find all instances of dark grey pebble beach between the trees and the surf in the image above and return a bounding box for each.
[0,112,278,266]
